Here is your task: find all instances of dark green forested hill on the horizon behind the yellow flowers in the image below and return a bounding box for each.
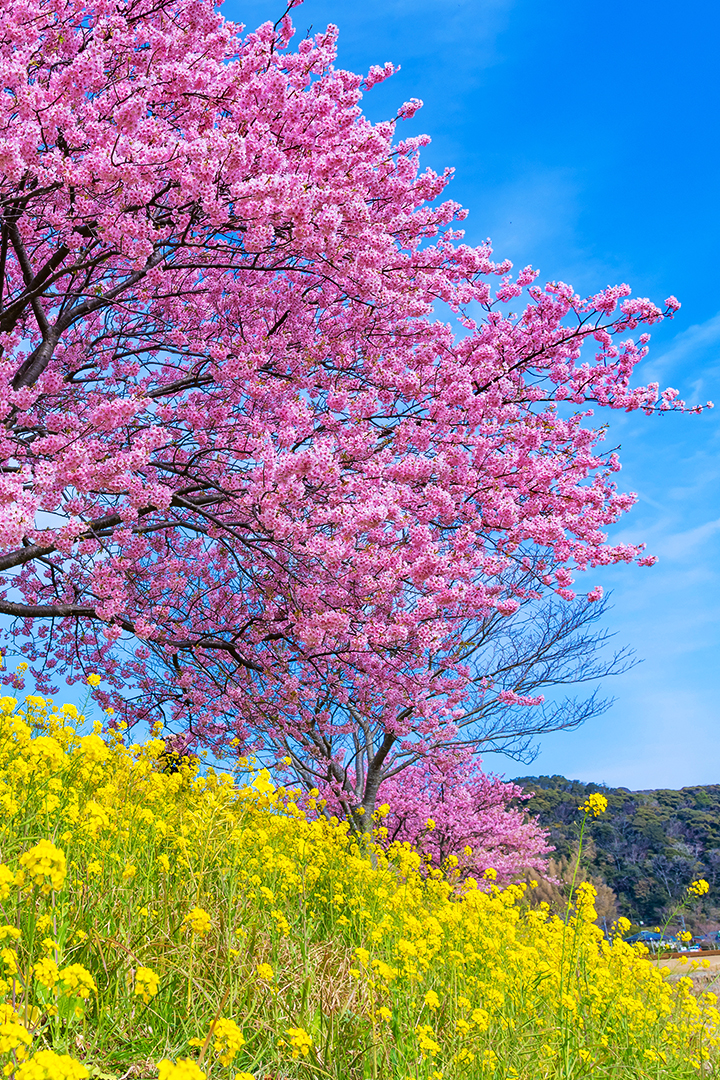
[515,777,720,926]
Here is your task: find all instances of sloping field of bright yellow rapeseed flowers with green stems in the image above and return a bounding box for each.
[0,697,720,1080]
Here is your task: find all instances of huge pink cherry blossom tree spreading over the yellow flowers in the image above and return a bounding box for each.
[0,0,708,827]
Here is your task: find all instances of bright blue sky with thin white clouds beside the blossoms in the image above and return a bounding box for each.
[232,0,720,788]
